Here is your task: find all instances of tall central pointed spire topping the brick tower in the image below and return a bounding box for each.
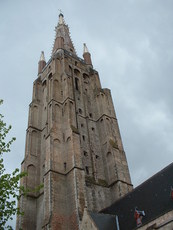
[52,13,76,55]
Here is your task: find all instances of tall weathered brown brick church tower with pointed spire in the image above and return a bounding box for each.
[16,14,132,230]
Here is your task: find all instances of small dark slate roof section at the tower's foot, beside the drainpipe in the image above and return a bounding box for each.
[89,212,117,230]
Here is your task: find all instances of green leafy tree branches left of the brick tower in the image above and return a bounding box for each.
[0,100,26,230]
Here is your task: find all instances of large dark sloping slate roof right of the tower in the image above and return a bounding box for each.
[101,163,173,230]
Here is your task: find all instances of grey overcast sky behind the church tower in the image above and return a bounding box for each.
[0,0,173,227]
